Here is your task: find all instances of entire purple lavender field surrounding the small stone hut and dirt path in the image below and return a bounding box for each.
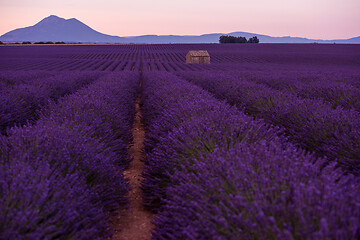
[0,44,360,240]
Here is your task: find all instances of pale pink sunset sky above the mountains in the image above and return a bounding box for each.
[0,0,360,39]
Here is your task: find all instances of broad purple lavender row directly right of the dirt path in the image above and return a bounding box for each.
[142,73,360,239]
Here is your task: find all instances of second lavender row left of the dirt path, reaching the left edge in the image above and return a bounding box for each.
[0,72,100,134]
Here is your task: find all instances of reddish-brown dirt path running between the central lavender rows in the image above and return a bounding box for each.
[113,97,153,240]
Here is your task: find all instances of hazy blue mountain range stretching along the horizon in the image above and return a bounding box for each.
[0,15,360,44]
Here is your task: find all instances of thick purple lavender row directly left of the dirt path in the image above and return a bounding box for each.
[0,72,139,239]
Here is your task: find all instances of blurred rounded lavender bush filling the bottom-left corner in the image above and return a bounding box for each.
[0,147,109,239]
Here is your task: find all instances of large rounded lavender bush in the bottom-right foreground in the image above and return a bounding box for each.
[153,141,360,239]
